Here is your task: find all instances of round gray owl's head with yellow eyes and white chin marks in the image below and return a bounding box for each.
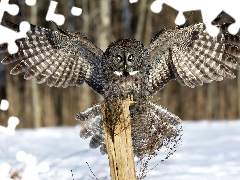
[102,39,148,77]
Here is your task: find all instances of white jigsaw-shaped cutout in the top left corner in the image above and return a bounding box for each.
[0,0,30,54]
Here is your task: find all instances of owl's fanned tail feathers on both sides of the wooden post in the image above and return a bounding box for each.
[76,101,181,158]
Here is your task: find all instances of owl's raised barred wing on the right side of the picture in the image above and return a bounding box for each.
[148,23,240,94]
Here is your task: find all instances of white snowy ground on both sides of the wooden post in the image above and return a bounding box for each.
[0,121,240,180]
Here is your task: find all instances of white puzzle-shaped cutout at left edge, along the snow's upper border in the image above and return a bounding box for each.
[0,116,19,136]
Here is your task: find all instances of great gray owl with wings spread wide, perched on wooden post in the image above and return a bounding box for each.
[0,11,240,156]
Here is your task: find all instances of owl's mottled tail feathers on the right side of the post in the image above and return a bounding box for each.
[131,101,181,159]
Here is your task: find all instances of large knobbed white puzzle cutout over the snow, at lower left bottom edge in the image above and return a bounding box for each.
[16,151,49,180]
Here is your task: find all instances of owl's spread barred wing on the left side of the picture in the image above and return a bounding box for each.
[0,21,103,94]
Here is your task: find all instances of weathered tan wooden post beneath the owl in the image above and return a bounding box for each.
[102,99,136,180]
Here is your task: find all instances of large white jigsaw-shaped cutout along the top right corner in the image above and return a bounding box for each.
[150,0,240,37]
